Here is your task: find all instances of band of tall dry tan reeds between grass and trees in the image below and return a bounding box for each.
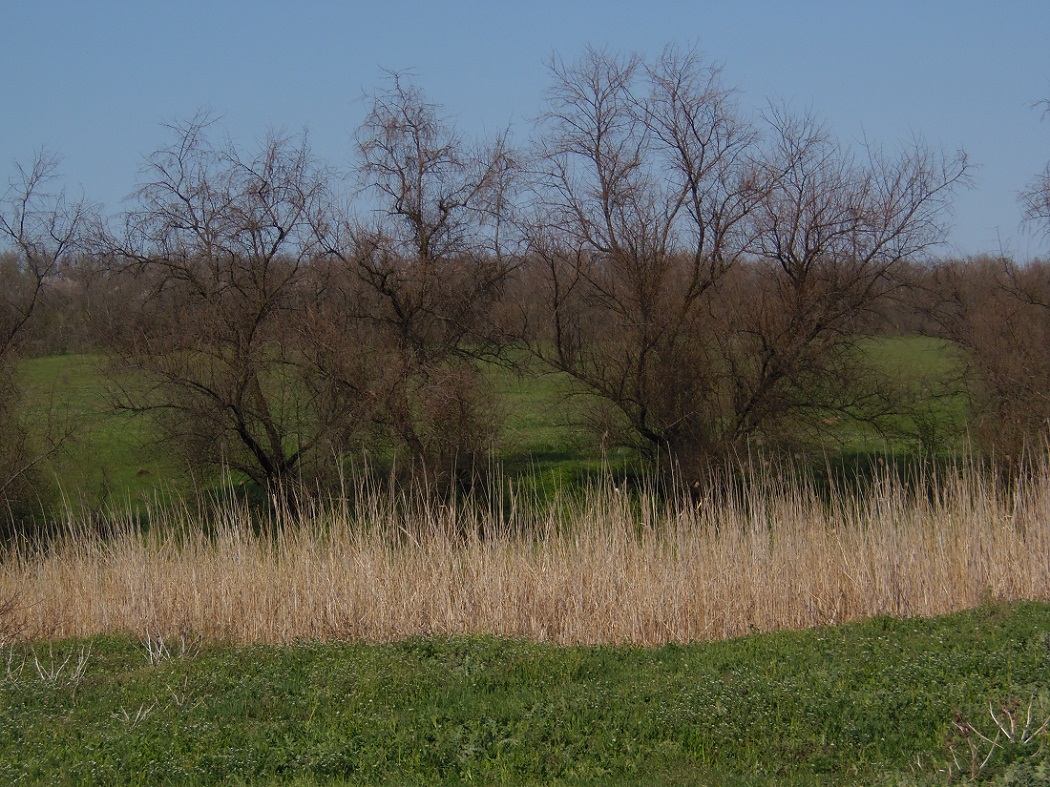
[0,472,1050,645]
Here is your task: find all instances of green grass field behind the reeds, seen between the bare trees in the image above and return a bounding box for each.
[12,337,966,509]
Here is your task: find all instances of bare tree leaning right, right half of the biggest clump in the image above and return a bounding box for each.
[716,108,967,443]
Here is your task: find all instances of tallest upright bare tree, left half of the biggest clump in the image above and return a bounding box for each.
[530,44,759,468]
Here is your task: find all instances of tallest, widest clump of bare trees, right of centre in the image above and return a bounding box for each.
[529,49,966,478]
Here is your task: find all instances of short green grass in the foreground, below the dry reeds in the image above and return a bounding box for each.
[0,603,1050,785]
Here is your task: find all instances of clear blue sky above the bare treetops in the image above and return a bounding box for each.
[0,0,1050,259]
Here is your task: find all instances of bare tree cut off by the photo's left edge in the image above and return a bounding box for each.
[0,151,88,526]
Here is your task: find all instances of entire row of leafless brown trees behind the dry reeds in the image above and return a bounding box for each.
[0,49,1047,518]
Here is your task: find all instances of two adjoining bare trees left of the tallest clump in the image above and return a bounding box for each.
[102,78,513,489]
